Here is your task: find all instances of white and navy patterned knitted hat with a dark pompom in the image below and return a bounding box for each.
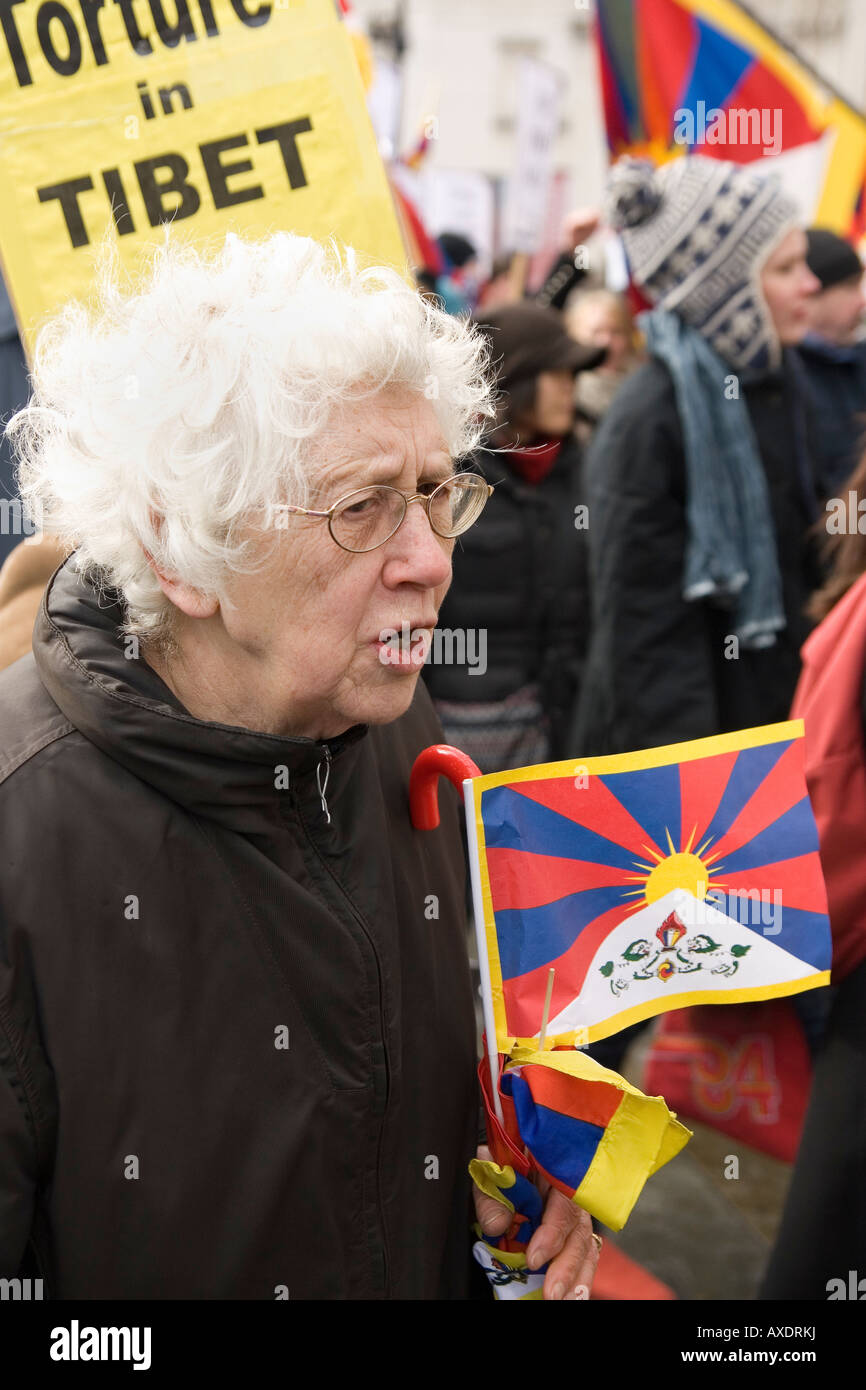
[605,154,801,368]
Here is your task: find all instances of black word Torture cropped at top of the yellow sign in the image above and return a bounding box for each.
[0,0,272,86]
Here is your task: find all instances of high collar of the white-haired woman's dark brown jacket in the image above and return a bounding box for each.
[33,559,368,831]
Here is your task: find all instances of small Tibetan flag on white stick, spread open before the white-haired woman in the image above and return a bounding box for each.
[464,720,831,1055]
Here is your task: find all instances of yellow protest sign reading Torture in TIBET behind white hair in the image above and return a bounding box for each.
[0,0,405,346]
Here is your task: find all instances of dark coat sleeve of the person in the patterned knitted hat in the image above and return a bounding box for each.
[571,361,719,756]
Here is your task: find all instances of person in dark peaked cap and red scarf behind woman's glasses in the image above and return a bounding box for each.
[425,302,605,773]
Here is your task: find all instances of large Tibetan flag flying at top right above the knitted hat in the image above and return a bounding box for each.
[596,0,866,238]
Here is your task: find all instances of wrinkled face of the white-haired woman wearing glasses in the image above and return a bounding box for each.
[215,391,459,738]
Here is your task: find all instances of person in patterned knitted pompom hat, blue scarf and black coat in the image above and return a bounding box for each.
[569,156,819,758]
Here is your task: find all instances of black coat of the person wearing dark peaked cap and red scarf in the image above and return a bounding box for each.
[424,438,589,758]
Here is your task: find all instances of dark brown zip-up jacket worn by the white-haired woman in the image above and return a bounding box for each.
[0,566,478,1300]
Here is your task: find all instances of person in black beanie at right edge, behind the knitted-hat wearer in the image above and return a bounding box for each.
[798,227,866,498]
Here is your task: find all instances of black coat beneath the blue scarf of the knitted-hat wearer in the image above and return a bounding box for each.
[567,359,820,758]
